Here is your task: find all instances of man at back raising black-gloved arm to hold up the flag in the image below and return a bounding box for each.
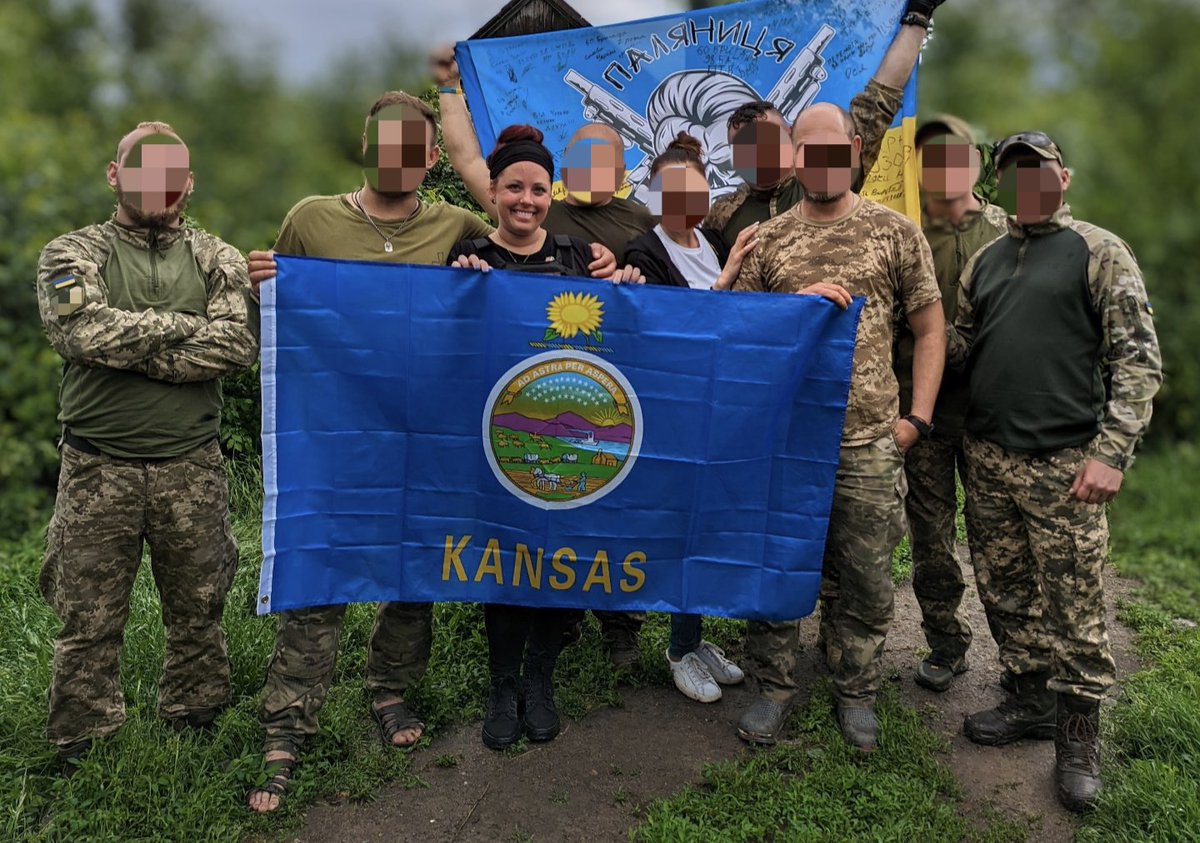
[703,0,946,244]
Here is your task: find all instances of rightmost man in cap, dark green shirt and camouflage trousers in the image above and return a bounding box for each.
[950,132,1162,811]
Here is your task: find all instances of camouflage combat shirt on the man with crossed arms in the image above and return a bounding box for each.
[37,220,258,459]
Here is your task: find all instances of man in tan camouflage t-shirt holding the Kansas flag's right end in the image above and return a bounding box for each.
[734,103,946,752]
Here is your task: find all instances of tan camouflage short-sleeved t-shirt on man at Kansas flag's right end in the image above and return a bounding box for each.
[733,197,942,446]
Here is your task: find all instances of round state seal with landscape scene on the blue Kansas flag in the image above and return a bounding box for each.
[484,348,642,509]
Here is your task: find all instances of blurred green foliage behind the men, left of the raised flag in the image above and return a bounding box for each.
[0,0,474,539]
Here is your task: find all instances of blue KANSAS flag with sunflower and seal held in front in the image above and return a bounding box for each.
[259,257,860,618]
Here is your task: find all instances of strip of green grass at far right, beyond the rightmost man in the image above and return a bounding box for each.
[1078,446,1200,843]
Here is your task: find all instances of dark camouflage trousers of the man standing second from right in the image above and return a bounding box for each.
[904,431,971,660]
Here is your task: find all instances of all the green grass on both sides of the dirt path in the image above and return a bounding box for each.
[7,449,1200,843]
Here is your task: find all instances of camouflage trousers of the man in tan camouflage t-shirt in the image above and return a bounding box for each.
[746,431,905,703]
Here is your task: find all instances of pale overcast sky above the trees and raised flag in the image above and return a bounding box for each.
[120,0,684,82]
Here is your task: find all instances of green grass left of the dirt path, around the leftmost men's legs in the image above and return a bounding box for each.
[0,465,744,843]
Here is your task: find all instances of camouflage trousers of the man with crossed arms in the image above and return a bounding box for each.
[40,441,238,746]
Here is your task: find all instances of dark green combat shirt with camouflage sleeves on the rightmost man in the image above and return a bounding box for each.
[947,205,1163,471]
